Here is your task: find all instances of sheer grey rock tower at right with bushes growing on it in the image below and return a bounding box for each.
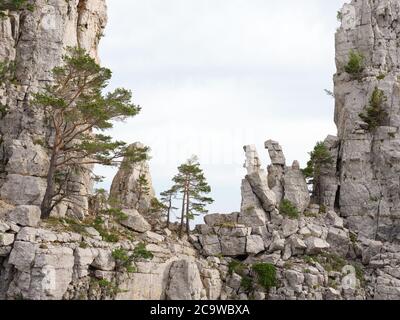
[334,0,400,241]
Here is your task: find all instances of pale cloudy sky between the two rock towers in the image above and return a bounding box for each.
[97,0,346,218]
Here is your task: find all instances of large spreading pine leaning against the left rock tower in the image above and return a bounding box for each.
[33,48,147,219]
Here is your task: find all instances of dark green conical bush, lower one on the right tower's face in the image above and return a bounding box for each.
[359,87,388,132]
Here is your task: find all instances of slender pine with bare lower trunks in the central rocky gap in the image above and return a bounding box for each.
[173,156,214,238]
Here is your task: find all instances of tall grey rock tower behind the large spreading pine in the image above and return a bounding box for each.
[0,0,107,218]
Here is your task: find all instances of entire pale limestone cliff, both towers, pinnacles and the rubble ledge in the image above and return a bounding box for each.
[0,0,400,300]
